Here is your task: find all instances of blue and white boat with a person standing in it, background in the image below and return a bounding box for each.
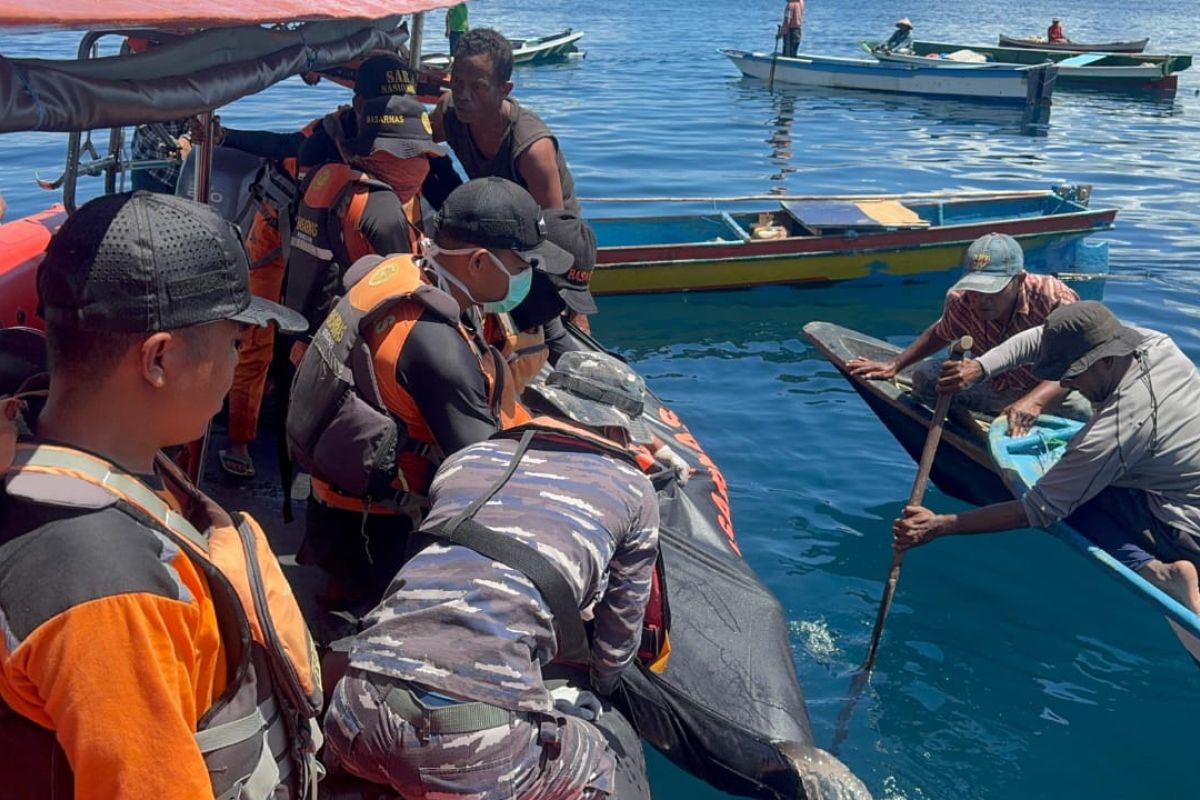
[718,49,1058,106]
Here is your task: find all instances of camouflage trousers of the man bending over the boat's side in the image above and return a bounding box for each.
[325,669,614,800]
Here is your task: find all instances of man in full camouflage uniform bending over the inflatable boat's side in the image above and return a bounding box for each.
[325,354,659,800]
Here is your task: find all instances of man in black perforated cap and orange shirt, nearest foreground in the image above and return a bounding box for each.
[0,192,322,800]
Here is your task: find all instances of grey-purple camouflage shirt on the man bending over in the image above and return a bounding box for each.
[350,439,659,711]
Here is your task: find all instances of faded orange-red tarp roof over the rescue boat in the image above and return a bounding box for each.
[0,0,455,29]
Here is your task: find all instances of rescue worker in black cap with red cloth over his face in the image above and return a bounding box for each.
[284,95,444,345]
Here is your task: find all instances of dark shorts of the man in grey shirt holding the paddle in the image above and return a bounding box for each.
[1067,486,1200,572]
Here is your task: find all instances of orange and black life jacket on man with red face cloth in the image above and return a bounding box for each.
[284,163,421,330]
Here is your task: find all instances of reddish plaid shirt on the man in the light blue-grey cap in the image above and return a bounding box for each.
[934,272,1079,392]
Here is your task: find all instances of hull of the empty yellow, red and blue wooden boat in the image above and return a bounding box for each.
[588,192,1116,295]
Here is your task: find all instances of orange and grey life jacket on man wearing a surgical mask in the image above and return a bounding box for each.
[287,255,529,513]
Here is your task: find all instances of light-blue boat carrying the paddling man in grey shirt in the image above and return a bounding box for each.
[988,416,1200,663]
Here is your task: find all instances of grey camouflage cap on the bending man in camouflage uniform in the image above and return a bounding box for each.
[529,350,654,444]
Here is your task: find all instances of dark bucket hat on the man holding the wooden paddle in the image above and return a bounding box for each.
[1030,300,1145,380]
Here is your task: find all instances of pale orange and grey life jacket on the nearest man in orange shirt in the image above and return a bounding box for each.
[0,441,322,800]
